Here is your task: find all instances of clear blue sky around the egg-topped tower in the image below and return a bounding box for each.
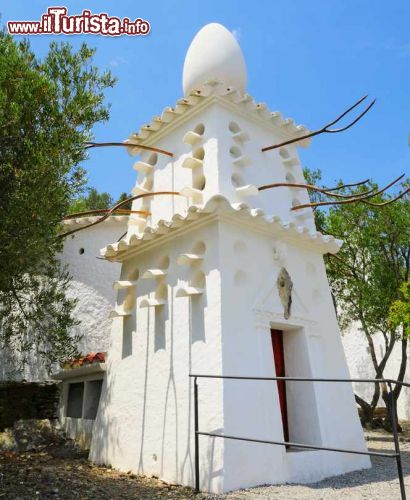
[0,0,410,197]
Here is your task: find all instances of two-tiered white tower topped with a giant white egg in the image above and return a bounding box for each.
[90,24,370,493]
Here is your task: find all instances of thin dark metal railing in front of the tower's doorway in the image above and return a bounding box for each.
[189,374,410,500]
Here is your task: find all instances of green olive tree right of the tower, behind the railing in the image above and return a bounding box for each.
[305,170,410,421]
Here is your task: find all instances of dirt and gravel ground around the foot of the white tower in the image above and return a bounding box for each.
[0,433,410,500]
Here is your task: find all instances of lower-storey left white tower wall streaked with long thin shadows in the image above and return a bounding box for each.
[90,226,223,490]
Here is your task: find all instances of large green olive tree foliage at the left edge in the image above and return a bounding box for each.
[0,31,115,366]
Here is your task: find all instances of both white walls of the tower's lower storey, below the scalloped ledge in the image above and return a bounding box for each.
[90,215,369,492]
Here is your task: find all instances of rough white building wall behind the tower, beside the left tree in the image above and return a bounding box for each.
[0,217,128,381]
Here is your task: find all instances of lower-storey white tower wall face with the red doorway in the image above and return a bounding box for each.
[221,222,369,490]
